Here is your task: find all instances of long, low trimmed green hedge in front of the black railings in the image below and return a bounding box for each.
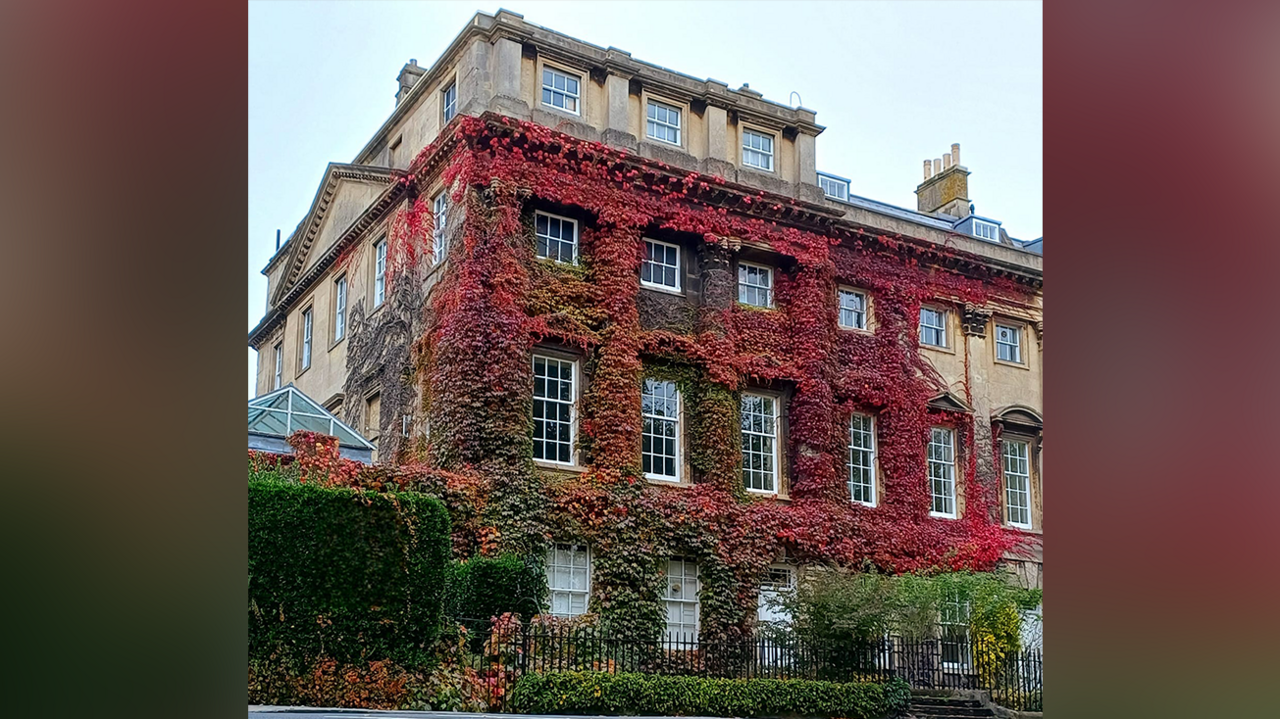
[511,672,911,719]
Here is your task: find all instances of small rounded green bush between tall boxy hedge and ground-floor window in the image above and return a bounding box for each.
[444,554,547,622]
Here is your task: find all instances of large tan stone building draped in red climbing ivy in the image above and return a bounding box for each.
[250,12,1043,633]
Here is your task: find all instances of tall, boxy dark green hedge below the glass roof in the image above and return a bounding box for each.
[248,480,449,667]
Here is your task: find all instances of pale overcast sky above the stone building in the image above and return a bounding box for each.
[247,0,1043,397]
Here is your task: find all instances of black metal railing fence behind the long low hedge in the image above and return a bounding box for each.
[450,626,1043,711]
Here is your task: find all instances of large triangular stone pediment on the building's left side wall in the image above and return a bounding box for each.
[271,162,394,304]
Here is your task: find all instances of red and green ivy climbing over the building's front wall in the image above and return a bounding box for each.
[381,116,1033,637]
